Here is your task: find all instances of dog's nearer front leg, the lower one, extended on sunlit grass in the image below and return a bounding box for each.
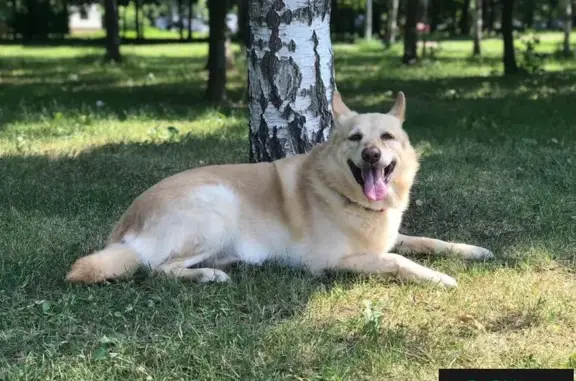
[337,253,457,288]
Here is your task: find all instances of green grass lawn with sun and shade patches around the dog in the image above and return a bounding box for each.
[0,35,576,381]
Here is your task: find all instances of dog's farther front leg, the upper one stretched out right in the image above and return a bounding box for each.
[394,234,494,259]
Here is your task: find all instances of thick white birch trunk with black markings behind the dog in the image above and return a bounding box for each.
[247,0,335,162]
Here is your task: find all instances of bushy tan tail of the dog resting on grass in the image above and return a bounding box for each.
[66,243,141,283]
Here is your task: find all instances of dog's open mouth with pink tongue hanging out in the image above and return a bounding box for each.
[348,160,396,201]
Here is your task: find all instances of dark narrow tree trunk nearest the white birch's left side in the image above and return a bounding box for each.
[206,0,227,103]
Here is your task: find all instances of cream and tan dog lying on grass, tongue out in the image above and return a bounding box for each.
[66,91,493,288]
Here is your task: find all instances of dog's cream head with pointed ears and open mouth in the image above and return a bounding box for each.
[329,91,418,208]
